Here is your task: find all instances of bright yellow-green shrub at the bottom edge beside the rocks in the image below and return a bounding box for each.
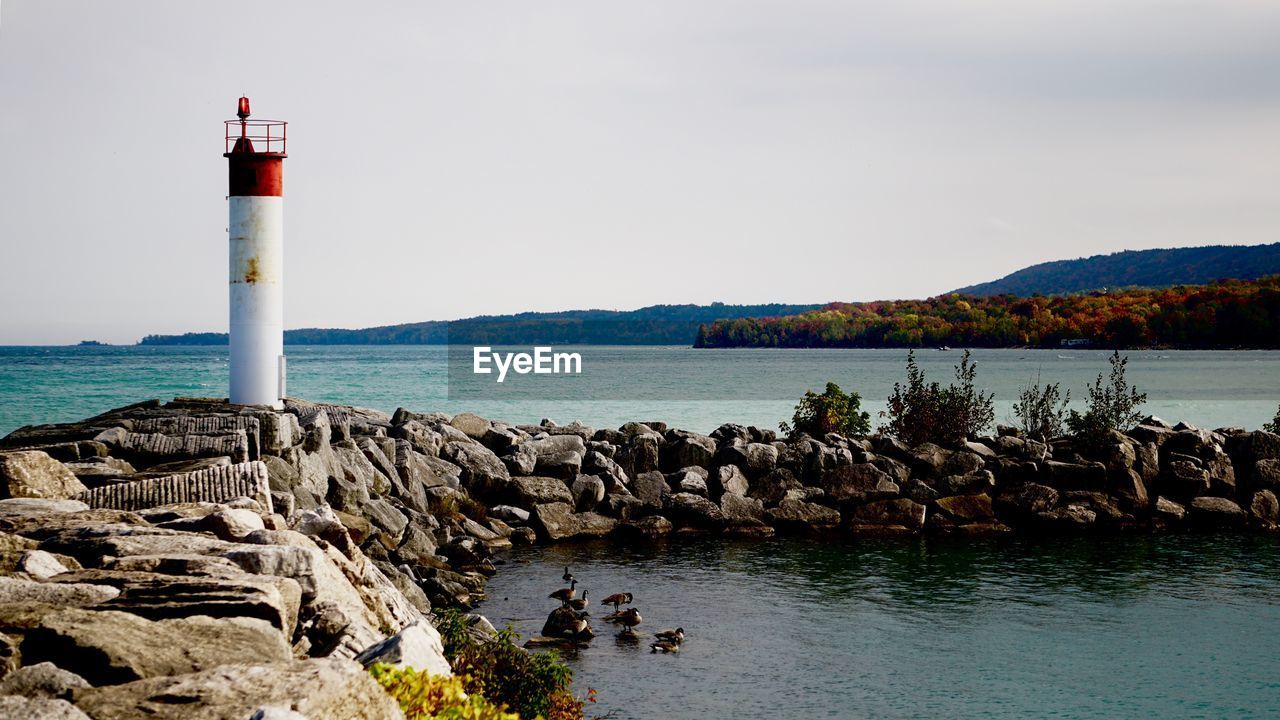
[369,664,520,720]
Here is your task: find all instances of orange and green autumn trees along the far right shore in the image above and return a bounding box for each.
[696,275,1280,348]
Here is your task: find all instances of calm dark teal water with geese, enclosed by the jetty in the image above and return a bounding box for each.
[479,536,1280,719]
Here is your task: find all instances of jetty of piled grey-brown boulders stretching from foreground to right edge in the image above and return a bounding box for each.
[0,398,1280,720]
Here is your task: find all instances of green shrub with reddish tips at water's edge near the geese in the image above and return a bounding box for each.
[438,609,594,720]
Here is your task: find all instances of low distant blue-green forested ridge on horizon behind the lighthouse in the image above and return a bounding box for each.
[140,302,820,345]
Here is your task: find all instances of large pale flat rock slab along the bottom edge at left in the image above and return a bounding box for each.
[73,660,404,720]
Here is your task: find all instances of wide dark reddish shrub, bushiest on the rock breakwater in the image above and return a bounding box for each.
[881,350,996,446]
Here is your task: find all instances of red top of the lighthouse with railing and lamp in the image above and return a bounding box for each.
[223,97,288,197]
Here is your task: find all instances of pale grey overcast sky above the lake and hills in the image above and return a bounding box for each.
[0,0,1280,345]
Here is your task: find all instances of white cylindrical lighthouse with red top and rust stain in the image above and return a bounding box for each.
[223,97,287,409]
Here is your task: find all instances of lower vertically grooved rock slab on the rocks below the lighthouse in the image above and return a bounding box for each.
[77,460,273,512]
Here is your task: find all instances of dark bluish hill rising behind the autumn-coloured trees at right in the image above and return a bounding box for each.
[955,242,1280,297]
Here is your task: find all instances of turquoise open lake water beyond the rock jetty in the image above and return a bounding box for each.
[0,346,1280,434]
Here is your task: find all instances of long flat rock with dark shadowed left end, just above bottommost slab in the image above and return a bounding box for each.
[22,610,292,681]
